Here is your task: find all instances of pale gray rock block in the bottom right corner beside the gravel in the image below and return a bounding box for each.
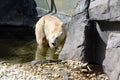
[103,48,120,80]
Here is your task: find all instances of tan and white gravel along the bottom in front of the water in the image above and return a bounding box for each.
[0,60,109,80]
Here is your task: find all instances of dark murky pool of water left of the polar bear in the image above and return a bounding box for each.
[0,25,37,63]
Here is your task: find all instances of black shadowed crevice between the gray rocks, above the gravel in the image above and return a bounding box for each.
[83,21,106,64]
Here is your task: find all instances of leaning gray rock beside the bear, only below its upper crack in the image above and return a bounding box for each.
[59,14,84,60]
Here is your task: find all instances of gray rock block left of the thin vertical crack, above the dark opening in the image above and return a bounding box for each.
[89,0,110,20]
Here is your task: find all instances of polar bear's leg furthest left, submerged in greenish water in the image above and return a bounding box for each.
[35,45,48,60]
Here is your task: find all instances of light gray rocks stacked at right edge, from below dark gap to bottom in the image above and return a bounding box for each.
[103,32,120,80]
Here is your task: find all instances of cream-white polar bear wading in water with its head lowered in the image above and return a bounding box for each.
[35,15,67,60]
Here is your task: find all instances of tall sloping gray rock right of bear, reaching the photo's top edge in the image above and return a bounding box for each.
[59,0,88,60]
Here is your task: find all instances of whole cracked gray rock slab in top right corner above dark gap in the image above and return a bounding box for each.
[89,0,120,21]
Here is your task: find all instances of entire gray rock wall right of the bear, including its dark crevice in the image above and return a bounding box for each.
[59,0,120,80]
